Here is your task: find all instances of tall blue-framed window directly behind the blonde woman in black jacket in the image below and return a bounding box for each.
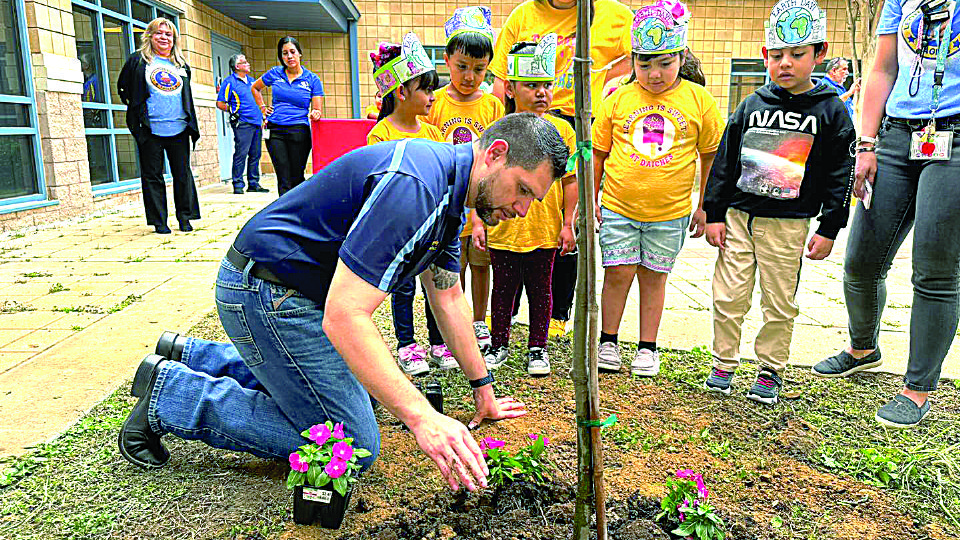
[73,0,178,195]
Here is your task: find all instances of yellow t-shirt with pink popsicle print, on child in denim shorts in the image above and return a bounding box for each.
[593,79,724,221]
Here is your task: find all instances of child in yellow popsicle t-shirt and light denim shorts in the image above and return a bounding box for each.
[593,0,723,377]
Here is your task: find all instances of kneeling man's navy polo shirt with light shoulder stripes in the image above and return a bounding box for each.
[233,139,473,304]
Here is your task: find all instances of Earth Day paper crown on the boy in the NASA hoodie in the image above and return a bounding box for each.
[763,0,827,49]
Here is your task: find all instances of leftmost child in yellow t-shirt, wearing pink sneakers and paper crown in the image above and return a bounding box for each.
[367,33,448,375]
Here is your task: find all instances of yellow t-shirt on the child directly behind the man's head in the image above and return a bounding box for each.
[487,114,577,253]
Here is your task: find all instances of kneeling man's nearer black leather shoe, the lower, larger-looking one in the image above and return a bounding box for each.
[117,354,170,469]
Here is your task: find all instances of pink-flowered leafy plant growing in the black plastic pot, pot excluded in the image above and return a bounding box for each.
[287,420,371,496]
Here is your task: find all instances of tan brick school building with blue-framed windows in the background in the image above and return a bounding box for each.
[0,0,868,232]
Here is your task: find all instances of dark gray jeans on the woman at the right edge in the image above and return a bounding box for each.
[843,120,960,392]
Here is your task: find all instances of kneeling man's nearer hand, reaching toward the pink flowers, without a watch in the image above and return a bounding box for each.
[410,411,490,491]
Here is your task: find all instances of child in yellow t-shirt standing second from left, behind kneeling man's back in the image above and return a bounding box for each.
[427,7,503,352]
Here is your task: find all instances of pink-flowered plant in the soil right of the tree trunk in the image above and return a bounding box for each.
[657,469,725,540]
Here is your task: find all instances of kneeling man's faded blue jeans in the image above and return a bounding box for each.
[148,259,380,468]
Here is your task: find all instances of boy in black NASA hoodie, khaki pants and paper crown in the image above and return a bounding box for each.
[703,0,856,404]
